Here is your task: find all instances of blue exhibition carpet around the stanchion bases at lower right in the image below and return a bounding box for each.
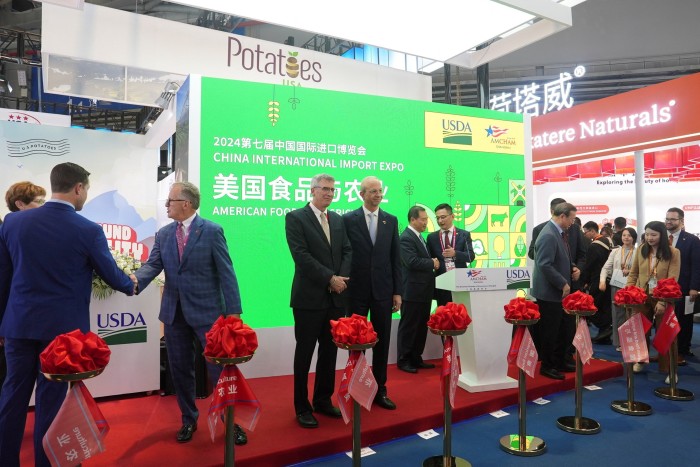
[296,324,700,467]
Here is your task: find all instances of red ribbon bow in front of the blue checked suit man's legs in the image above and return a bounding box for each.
[204,315,258,358]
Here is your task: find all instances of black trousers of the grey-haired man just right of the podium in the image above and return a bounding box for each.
[533,300,576,369]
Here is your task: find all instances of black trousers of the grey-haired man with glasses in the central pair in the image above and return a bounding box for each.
[293,307,343,414]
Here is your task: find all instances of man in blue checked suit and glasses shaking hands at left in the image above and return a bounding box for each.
[136,182,247,444]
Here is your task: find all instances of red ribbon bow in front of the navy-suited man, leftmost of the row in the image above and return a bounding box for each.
[39,329,112,374]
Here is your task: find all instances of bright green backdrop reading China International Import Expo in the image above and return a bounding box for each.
[197,78,527,328]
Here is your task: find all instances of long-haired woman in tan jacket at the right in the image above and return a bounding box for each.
[627,221,681,373]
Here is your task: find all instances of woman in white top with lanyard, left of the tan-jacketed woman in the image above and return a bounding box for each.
[598,227,637,352]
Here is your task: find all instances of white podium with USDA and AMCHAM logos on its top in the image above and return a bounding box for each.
[435,268,530,392]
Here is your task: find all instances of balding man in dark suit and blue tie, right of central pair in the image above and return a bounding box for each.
[343,177,403,410]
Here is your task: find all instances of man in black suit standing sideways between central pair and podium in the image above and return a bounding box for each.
[396,206,440,373]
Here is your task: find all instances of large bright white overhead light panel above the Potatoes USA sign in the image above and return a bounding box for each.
[167,0,585,68]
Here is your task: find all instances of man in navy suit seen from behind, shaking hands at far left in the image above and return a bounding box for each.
[0,162,134,467]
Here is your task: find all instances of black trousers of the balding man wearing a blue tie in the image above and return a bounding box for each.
[348,299,393,394]
